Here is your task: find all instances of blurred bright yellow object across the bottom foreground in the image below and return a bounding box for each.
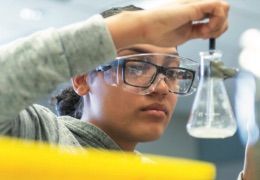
[0,138,215,180]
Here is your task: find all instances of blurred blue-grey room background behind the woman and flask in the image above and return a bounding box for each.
[0,0,260,180]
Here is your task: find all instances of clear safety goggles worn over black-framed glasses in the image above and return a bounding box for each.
[98,53,198,95]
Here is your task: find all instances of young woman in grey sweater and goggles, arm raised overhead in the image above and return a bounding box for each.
[0,0,250,179]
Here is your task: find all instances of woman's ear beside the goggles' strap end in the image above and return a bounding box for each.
[71,74,89,96]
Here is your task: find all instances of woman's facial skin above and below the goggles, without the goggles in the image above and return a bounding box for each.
[84,45,177,148]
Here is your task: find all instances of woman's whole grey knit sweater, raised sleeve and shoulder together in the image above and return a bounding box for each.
[0,15,120,149]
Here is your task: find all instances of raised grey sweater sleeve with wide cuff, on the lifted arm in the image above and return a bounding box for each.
[0,15,116,134]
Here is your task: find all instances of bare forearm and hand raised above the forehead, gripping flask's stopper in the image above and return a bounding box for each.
[106,0,229,48]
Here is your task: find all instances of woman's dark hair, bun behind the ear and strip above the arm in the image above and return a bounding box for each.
[53,5,143,119]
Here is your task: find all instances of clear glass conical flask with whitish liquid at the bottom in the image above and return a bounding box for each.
[187,50,237,138]
